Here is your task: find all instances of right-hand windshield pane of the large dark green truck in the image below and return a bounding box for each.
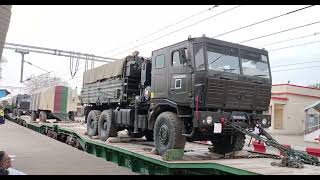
[240,50,270,78]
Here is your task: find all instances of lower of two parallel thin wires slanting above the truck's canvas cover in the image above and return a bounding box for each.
[111,5,241,57]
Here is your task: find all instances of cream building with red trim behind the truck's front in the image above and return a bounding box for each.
[269,84,320,135]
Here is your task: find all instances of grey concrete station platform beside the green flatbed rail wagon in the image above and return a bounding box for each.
[0,121,136,175]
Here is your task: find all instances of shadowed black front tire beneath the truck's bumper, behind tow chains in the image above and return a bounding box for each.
[211,133,246,154]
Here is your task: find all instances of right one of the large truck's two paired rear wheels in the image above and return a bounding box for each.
[98,110,118,141]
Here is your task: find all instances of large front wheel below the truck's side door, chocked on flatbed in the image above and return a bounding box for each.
[153,112,186,156]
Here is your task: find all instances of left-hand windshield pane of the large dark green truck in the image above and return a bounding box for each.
[207,47,240,74]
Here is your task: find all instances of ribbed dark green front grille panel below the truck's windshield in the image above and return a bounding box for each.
[206,78,271,110]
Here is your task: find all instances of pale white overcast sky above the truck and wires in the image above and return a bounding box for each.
[0,5,320,92]
